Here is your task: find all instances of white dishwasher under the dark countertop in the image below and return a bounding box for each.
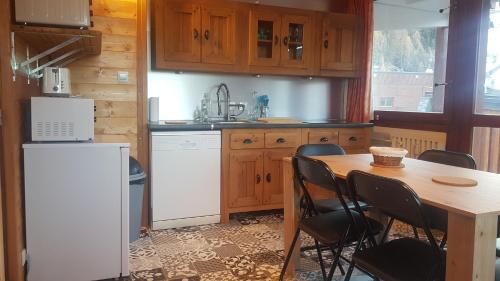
[151,131,221,229]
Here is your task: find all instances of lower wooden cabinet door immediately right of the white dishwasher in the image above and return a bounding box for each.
[228,151,264,208]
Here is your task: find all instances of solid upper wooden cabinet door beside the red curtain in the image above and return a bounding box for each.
[321,14,361,71]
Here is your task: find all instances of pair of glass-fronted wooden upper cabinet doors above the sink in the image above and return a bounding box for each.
[250,8,312,68]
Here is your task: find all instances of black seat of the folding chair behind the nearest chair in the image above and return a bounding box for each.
[299,210,384,245]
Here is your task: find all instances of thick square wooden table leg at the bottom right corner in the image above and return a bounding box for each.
[446,213,498,281]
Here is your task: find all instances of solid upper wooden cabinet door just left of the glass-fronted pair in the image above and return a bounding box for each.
[201,6,236,64]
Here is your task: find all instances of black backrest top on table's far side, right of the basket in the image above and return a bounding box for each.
[418,149,476,170]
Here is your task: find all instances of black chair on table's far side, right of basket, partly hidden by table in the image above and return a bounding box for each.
[417,149,476,248]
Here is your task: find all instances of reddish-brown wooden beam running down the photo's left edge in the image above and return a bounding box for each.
[0,0,40,281]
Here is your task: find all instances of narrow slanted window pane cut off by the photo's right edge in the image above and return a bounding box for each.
[475,1,500,115]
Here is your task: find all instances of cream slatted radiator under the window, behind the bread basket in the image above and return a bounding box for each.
[374,127,446,158]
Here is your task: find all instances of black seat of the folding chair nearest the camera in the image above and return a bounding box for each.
[352,238,445,281]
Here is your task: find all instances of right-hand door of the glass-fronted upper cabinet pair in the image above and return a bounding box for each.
[281,15,312,68]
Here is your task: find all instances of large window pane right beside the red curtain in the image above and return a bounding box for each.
[372,0,450,113]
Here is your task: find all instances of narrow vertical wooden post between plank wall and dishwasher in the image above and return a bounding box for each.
[136,0,150,226]
